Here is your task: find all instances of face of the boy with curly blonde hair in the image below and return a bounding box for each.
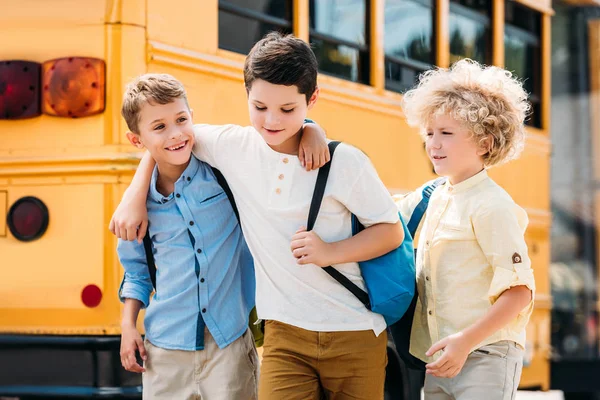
[425,115,487,185]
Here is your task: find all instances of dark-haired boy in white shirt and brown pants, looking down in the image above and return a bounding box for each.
[111,33,404,400]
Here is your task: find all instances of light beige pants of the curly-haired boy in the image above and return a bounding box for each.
[425,341,523,400]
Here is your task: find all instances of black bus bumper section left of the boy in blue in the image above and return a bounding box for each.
[0,335,142,399]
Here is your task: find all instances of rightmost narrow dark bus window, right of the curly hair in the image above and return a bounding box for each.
[504,1,541,128]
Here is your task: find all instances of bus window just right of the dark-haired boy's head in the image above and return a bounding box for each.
[309,0,369,84]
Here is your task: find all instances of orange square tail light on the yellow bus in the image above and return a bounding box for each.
[42,57,106,118]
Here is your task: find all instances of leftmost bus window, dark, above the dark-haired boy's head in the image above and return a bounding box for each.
[219,0,293,54]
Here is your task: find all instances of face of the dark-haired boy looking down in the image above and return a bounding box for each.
[248,79,319,154]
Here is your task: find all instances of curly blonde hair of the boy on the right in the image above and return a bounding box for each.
[402,59,530,167]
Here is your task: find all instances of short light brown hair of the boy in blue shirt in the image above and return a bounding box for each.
[121,74,189,133]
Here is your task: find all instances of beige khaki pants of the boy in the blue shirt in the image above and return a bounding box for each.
[142,329,258,400]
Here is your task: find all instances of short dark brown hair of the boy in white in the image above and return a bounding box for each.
[244,32,318,103]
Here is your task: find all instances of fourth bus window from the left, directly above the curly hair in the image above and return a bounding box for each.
[449,0,492,64]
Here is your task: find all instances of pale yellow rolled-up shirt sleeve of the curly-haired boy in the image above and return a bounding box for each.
[472,202,535,316]
